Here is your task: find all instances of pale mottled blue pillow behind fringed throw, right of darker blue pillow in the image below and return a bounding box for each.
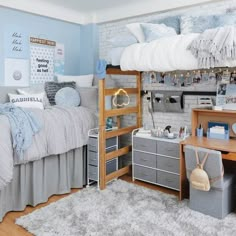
[180,15,218,34]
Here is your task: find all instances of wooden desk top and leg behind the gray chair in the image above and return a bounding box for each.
[180,136,236,200]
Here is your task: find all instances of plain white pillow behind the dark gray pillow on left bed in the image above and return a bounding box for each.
[57,74,93,87]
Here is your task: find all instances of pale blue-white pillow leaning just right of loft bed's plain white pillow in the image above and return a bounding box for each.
[141,23,176,42]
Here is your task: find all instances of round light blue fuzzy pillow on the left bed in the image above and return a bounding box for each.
[55,87,80,107]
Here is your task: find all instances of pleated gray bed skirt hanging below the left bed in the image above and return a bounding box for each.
[0,146,86,222]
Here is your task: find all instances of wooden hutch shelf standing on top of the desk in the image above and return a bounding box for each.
[192,108,236,137]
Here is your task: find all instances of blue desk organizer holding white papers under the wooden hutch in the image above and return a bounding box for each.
[207,121,229,140]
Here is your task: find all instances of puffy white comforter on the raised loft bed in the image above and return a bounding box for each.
[120,33,236,72]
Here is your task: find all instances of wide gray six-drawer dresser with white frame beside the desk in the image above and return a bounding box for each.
[132,132,180,191]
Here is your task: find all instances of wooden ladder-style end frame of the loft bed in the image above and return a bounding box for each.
[99,67,142,190]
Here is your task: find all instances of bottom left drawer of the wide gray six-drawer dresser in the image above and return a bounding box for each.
[133,165,157,183]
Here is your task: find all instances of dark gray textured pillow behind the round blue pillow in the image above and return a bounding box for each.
[44,81,76,105]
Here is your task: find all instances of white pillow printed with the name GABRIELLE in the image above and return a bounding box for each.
[8,93,44,109]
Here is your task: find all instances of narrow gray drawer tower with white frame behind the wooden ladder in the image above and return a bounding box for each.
[87,128,118,187]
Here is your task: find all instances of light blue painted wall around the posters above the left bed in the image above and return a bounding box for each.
[0,7,98,84]
